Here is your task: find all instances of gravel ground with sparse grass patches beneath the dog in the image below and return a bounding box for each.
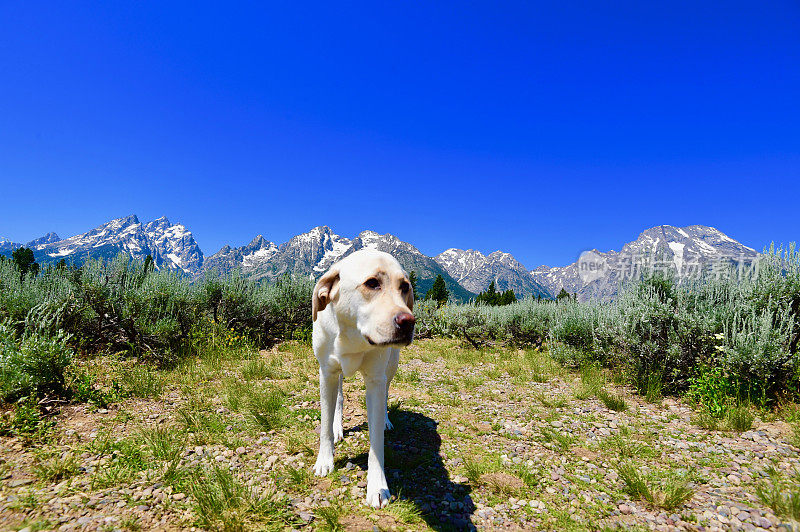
[0,341,800,531]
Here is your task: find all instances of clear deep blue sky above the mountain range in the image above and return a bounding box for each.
[0,0,800,268]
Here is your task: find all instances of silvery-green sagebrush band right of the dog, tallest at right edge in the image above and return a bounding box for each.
[422,247,800,404]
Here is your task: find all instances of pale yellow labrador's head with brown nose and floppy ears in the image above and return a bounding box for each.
[312,249,416,345]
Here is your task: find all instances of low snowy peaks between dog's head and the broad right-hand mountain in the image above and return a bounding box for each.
[434,248,551,297]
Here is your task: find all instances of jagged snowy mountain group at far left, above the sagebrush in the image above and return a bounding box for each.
[19,215,203,277]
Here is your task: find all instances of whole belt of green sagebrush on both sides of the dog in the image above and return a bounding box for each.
[0,243,800,410]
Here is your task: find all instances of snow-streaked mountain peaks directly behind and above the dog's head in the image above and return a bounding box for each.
[205,226,474,300]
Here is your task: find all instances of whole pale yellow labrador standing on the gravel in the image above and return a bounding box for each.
[312,249,416,508]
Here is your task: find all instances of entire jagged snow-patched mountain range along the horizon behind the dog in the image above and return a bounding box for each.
[0,215,757,301]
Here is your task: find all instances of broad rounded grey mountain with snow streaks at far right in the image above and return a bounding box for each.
[531,225,758,301]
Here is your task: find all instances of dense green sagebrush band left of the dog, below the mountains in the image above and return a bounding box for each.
[0,254,313,365]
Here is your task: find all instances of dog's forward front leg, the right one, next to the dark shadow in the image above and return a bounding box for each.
[364,374,389,508]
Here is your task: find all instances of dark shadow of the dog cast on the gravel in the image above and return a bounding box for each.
[336,408,475,531]
